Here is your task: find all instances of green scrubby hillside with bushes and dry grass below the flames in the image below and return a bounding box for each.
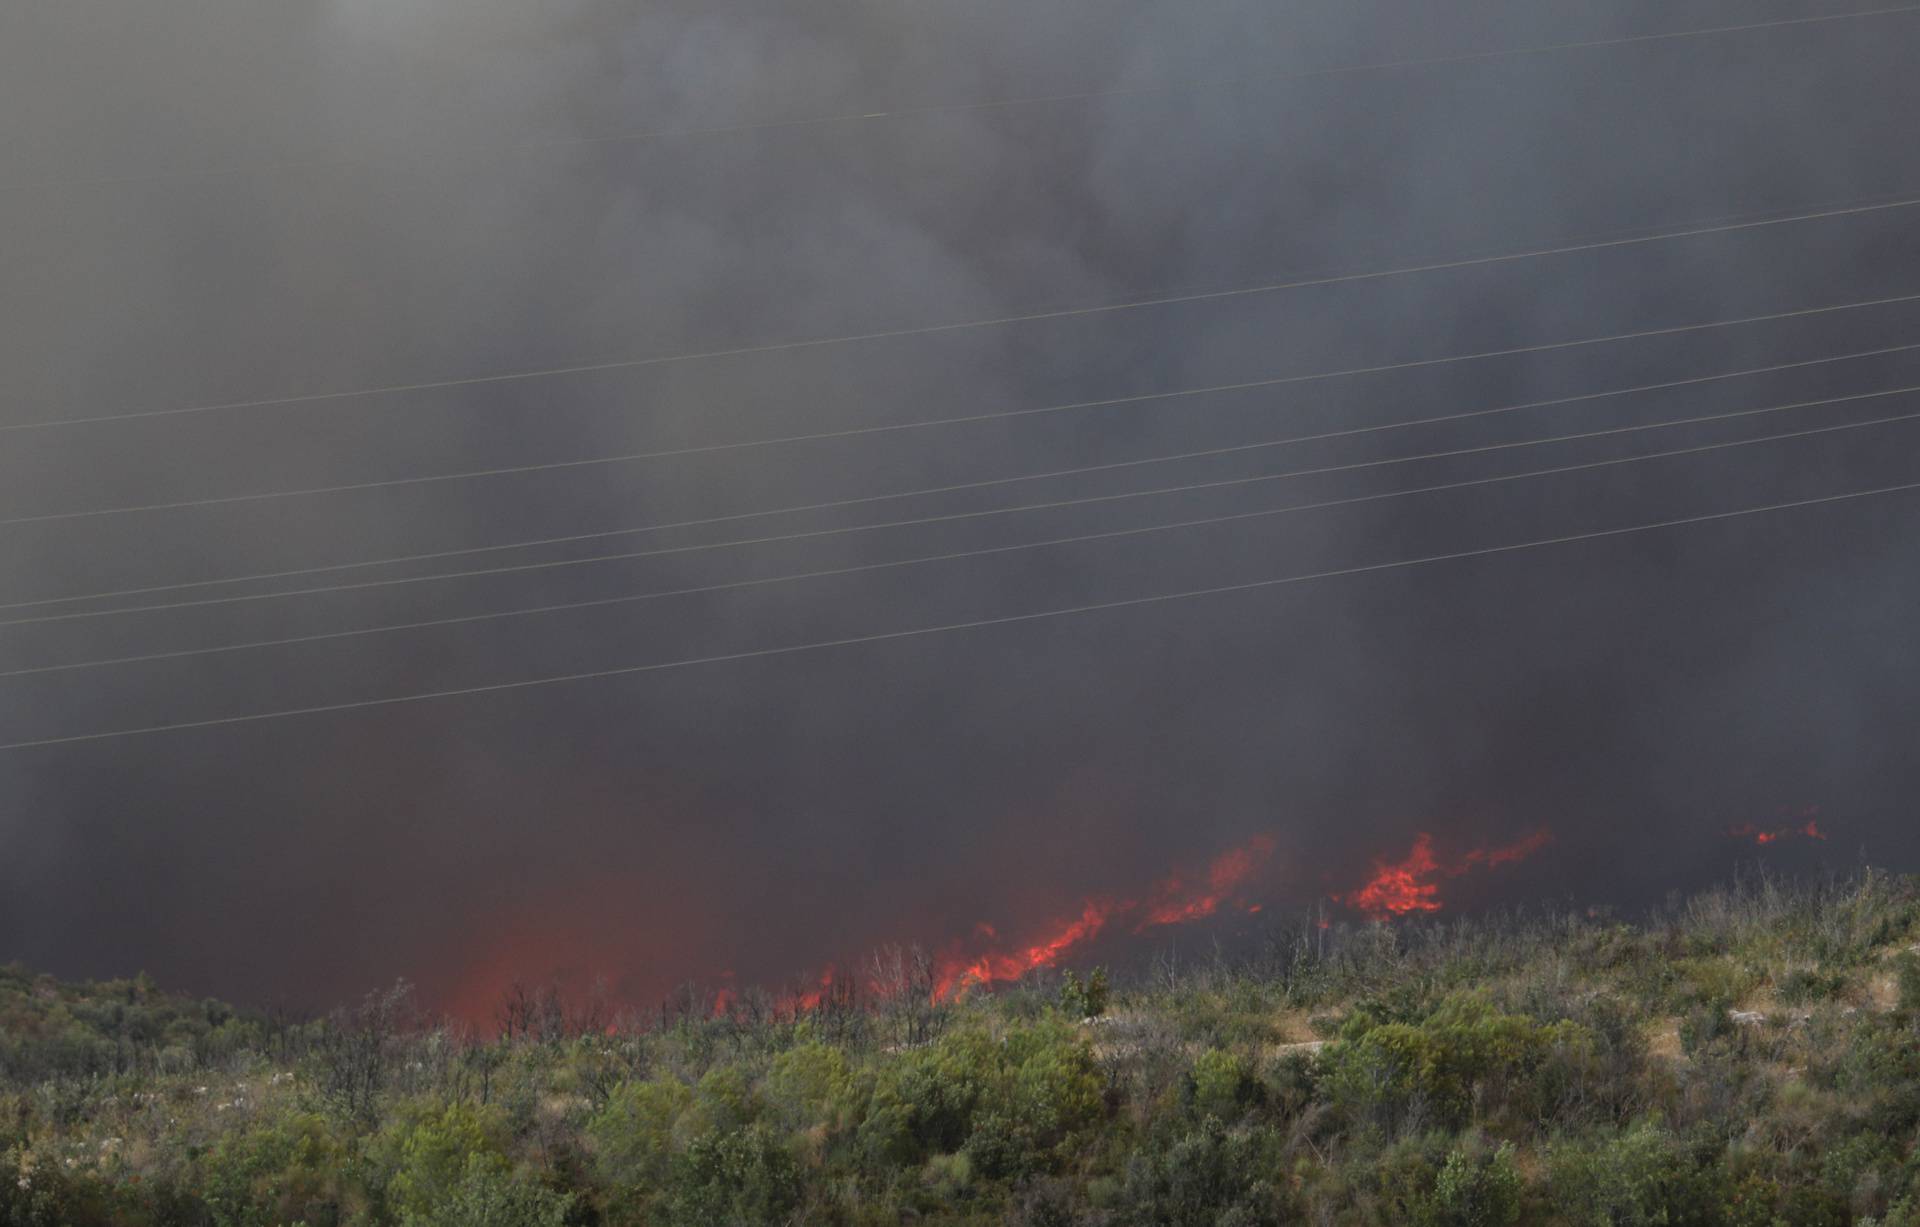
[11,874,1920,1227]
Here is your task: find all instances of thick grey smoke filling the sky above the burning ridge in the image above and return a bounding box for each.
[0,0,1920,1006]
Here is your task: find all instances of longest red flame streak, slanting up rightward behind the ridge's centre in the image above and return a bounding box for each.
[933,835,1275,998]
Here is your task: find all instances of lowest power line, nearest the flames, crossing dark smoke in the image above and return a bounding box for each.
[0,464,1920,751]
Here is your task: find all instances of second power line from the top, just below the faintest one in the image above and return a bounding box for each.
[0,196,1920,432]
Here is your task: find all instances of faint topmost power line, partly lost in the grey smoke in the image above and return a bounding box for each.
[0,4,1920,192]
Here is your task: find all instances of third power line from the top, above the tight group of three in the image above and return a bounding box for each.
[11,294,1920,529]
